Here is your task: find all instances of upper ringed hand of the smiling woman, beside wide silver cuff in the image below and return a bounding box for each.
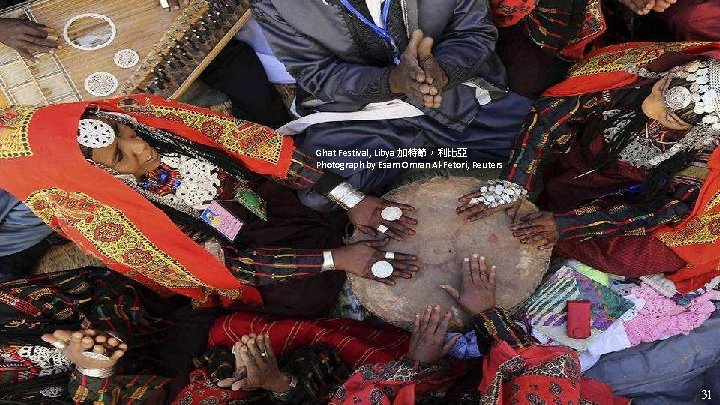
[348,195,417,240]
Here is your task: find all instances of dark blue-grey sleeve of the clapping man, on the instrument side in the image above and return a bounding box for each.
[253,1,396,104]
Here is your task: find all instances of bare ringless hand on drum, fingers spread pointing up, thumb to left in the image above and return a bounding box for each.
[440,254,497,316]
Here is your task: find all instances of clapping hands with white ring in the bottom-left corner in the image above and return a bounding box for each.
[42,329,127,369]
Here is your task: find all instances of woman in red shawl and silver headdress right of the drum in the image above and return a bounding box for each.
[458,43,720,292]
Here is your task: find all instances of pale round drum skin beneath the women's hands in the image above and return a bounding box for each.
[349,177,551,331]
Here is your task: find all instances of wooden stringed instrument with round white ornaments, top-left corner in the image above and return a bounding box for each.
[0,0,250,107]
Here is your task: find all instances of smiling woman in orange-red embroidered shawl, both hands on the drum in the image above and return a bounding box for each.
[0,95,417,315]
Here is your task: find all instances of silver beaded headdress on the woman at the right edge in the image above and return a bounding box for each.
[664,59,720,132]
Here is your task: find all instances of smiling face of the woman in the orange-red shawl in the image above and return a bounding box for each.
[92,122,160,179]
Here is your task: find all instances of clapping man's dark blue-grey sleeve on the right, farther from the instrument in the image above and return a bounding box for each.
[433,0,498,88]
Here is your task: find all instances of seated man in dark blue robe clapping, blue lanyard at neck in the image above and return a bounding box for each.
[253,0,531,210]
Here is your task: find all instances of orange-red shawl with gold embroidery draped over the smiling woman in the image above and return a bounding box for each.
[0,95,293,304]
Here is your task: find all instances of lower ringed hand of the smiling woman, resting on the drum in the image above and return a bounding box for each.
[332,238,420,285]
